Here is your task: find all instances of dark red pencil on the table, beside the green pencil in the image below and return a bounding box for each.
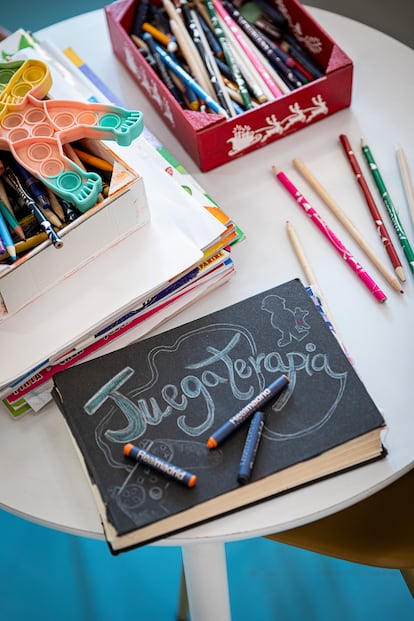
[339,134,405,281]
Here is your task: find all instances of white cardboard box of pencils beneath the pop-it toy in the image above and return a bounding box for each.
[0,141,150,320]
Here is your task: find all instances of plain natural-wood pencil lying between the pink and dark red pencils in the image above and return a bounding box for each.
[293,158,404,293]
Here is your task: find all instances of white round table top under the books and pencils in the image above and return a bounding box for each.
[0,9,414,545]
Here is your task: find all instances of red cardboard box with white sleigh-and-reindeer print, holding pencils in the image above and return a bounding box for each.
[105,0,353,171]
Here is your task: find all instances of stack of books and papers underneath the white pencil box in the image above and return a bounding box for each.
[0,30,243,418]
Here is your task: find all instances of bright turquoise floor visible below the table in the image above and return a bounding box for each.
[0,511,414,621]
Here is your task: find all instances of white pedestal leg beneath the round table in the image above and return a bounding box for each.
[182,543,231,621]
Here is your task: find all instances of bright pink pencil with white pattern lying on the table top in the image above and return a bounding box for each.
[272,166,387,302]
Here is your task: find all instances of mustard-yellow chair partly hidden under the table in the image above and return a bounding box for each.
[177,469,414,621]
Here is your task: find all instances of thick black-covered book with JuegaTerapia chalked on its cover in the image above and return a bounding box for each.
[53,280,384,553]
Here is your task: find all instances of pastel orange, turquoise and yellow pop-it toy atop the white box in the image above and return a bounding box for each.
[0,59,144,212]
